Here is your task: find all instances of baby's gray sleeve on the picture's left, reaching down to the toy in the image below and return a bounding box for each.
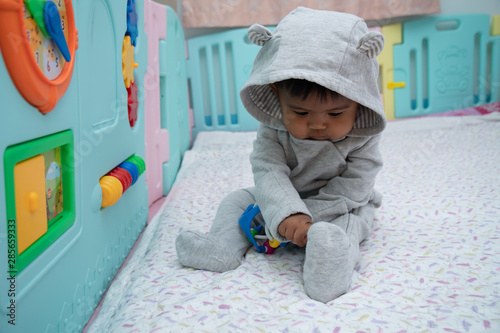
[250,125,311,242]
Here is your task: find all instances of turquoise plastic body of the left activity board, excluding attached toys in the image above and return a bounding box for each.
[0,0,148,333]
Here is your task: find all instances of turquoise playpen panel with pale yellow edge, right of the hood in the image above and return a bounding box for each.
[378,14,500,119]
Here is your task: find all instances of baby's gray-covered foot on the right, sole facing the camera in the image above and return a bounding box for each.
[304,222,359,303]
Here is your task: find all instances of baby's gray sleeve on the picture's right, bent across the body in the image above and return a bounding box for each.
[304,135,383,221]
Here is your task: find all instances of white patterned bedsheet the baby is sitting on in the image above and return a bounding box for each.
[89,113,500,333]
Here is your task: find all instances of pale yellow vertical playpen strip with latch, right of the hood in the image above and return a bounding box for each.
[377,23,405,120]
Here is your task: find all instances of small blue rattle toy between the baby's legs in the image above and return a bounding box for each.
[238,204,288,254]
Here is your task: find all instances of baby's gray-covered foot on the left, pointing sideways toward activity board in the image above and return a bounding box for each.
[175,230,243,272]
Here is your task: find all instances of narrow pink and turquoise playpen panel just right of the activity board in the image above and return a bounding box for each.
[144,0,192,204]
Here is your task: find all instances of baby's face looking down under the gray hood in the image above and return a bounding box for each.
[276,85,358,140]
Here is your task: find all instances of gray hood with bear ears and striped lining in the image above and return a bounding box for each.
[240,7,386,136]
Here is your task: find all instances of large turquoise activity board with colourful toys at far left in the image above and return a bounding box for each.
[0,0,148,333]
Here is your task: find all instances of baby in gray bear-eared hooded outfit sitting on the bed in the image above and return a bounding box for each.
[176,7,386,303]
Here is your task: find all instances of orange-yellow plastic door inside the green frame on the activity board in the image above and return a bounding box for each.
[14,155,47,254]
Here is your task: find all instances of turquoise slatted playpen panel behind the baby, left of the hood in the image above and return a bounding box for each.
[187,28,272,135]
